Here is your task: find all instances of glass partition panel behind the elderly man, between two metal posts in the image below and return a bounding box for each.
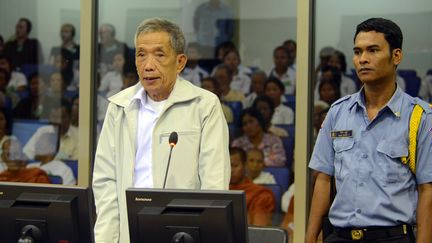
[95,0,297,237]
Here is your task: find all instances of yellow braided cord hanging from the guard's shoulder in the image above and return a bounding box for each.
[401,105,423,174]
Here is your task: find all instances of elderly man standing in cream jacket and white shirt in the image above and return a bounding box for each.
[93,18,230,243]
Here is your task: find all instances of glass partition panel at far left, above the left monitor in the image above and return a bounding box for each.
[0,0,80,185]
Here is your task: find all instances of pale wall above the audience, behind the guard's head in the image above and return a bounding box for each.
[315,0,432,77]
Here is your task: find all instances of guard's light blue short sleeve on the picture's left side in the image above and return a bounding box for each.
[309,108,335,175]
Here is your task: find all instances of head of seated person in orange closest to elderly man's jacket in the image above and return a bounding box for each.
[229,147,246,185]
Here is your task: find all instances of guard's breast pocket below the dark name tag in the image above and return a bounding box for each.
[333,138,354,178]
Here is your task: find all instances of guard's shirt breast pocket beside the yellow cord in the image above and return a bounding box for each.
[377,140,410,183]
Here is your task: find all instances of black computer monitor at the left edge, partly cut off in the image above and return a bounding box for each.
[0,182,94,243]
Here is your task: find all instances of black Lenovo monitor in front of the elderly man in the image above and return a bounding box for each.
[126,188,248,243]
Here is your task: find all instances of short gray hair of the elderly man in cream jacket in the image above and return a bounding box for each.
[135,18,185,54]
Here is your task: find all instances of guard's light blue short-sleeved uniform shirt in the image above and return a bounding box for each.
[309,88,432,227]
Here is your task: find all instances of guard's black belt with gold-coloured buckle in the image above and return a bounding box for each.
[334,224,412,240]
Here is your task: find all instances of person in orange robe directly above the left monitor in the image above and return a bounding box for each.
[0,139,50,183]
